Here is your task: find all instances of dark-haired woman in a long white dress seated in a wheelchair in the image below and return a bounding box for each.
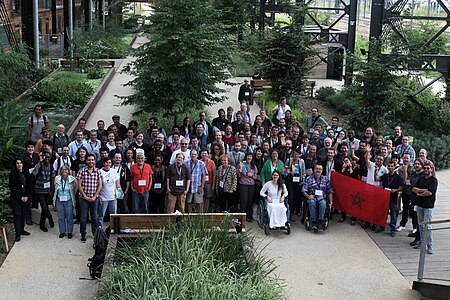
[260,170,288,228]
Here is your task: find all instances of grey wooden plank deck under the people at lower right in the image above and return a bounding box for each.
[366,176,450,280]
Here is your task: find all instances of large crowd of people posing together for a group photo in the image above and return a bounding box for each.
[10,95,437,253]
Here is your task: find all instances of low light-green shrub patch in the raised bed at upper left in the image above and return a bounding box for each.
[30,76,94,105]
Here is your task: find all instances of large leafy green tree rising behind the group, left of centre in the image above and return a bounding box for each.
[124,0,233,120]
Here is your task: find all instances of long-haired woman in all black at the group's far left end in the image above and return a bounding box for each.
[9,158,33,242]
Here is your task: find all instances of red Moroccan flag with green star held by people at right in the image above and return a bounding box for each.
[331,172,390,227]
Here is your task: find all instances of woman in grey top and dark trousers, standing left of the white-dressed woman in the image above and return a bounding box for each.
[239,153,258,222]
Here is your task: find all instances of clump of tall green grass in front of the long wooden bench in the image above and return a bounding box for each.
[95,218,285,300]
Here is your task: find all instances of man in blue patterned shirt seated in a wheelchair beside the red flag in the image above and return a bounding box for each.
[302,165,334,231]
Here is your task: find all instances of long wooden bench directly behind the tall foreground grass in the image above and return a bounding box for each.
[110,213,246,234]
